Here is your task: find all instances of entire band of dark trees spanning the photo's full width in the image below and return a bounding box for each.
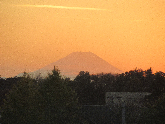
[0,68,165,124]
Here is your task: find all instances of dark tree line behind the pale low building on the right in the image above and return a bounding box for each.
[69,68,165,104]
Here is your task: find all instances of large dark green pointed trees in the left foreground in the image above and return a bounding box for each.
[1,69,78,124]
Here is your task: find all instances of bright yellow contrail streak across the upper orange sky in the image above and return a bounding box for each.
[13,5,107,11]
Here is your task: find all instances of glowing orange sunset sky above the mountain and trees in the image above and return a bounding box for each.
[0,0,165,77]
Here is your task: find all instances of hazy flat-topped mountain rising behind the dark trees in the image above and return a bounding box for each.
[17,52,123,79]
